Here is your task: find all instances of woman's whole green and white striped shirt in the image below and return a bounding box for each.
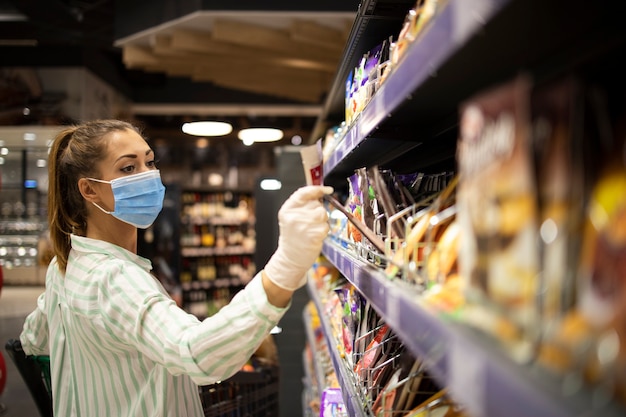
[20,235,286,417]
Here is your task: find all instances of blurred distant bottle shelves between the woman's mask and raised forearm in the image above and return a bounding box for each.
[180,189,256,317]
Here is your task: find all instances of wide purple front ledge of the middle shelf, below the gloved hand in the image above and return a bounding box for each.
[323,239,626,417]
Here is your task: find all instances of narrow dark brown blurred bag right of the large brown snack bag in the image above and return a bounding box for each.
[531,78,583,328]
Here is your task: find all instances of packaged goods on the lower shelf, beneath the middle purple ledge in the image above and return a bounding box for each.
[310,262,460,416]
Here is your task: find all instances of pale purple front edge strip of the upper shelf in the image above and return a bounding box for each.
[324,0,509,181]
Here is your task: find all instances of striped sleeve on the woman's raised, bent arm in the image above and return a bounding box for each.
[101,268,289,385]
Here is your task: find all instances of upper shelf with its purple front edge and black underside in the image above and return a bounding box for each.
[321,0,626,185]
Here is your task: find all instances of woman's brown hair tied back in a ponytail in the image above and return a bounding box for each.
[48,120,141,272]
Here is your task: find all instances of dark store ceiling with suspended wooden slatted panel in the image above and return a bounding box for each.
[0,0,359,150]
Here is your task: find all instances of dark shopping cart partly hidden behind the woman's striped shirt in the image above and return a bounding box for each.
[5,339,278,417]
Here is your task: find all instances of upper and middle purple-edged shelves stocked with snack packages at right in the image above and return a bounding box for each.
[310,0,626,417]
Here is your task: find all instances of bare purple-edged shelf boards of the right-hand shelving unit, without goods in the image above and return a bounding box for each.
[309,0,626,417]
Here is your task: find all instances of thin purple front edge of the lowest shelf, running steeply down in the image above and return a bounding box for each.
[308,280,369,417]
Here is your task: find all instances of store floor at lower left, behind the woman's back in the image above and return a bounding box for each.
[0,286,43,417]
